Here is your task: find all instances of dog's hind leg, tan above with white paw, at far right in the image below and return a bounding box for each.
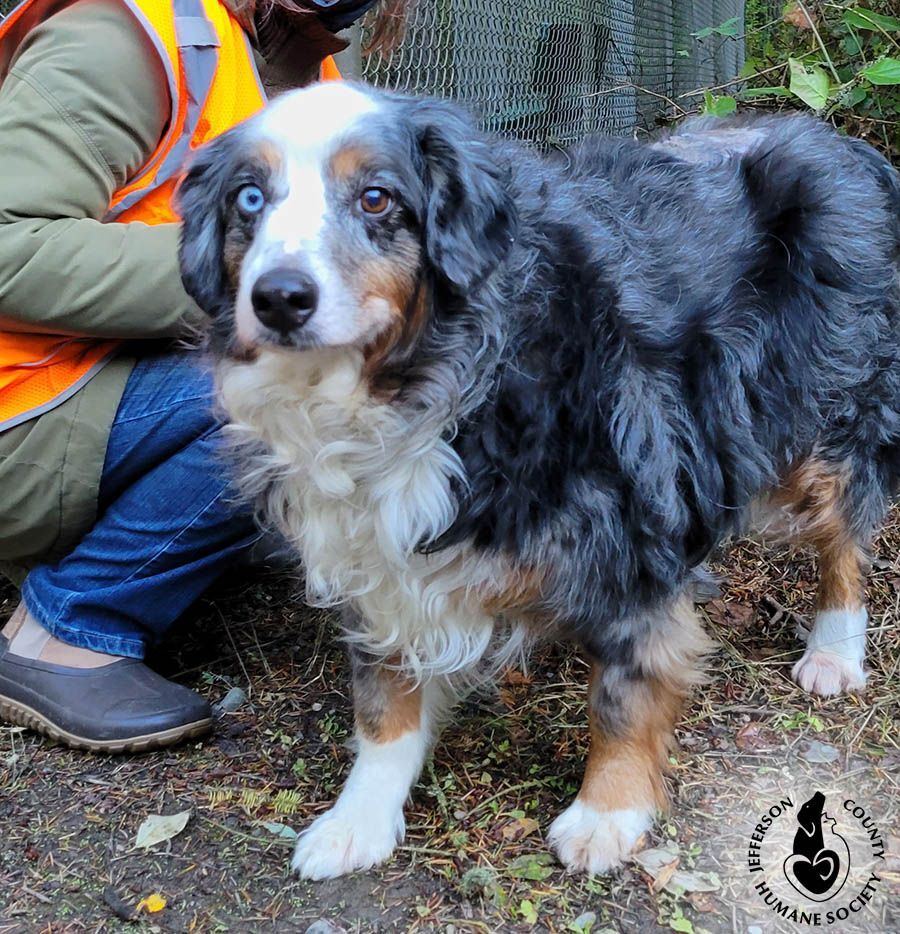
[779,459,883,697]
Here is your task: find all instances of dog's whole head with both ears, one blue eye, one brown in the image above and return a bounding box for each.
[179,83,515,366]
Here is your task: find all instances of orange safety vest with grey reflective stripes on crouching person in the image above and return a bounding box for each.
[0,0,340,431]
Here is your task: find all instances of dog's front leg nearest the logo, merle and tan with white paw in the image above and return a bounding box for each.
[549,597,711,873]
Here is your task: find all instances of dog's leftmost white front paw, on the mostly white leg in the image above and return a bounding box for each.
[291,807,405,879]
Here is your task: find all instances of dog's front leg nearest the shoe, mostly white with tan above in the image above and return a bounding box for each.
[292,651,450,879]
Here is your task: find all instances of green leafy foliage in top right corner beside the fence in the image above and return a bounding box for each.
[740,0,900,163]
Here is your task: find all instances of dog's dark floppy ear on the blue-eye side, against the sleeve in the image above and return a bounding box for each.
[176,133,233,317]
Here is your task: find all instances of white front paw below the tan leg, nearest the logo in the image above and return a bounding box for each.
[548,799,653,875]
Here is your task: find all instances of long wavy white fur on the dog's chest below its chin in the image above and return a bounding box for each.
[218,351,510,677]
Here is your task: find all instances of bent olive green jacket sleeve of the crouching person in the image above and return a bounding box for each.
[0,0,202,338]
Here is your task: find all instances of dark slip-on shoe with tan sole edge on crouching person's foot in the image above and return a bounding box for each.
[0,635,212,753]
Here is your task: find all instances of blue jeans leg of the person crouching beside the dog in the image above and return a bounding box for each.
[22,353,259,658]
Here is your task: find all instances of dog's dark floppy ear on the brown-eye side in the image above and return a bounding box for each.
[410,101,518,292]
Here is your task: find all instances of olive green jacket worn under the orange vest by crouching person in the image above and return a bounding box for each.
[0,0,346,578]
